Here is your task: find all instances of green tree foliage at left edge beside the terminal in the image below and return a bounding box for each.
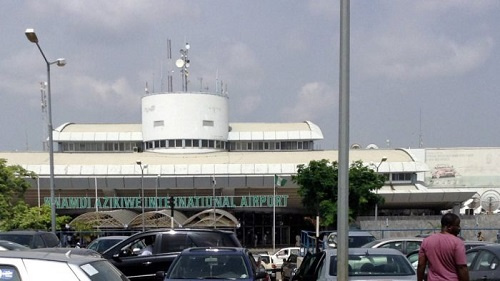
[0,159,71,231]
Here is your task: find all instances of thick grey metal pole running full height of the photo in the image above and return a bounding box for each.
[337,0,350,280]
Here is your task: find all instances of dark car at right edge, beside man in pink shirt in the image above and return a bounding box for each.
[466,244,500,281]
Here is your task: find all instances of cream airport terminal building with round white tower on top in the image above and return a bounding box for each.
[0,87,500,245]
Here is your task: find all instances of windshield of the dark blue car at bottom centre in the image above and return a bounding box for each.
[168,253,249,280]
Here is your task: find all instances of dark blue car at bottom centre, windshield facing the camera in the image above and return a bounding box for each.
[164,247,269,281]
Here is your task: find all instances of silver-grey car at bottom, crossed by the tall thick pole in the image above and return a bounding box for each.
[292,248,417,281]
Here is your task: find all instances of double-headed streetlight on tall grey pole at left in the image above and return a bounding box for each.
[25,28,66,234]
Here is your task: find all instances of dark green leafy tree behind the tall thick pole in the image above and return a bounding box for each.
[292,159,385,227]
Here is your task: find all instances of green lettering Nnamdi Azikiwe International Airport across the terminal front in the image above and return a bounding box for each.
[44,195,288,209]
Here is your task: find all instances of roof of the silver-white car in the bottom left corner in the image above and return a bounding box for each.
[0,250,105,265]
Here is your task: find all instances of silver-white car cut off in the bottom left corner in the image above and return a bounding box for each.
[0,250,128,281]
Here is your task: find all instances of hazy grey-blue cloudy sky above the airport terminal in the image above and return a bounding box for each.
[0,0,500,151]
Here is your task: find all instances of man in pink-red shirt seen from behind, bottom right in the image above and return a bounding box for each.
[417,213,469,281]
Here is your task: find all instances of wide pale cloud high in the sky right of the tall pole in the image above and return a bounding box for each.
[360,36,493,80]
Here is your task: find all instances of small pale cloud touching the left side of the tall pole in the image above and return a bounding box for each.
[280,82,338,121]
